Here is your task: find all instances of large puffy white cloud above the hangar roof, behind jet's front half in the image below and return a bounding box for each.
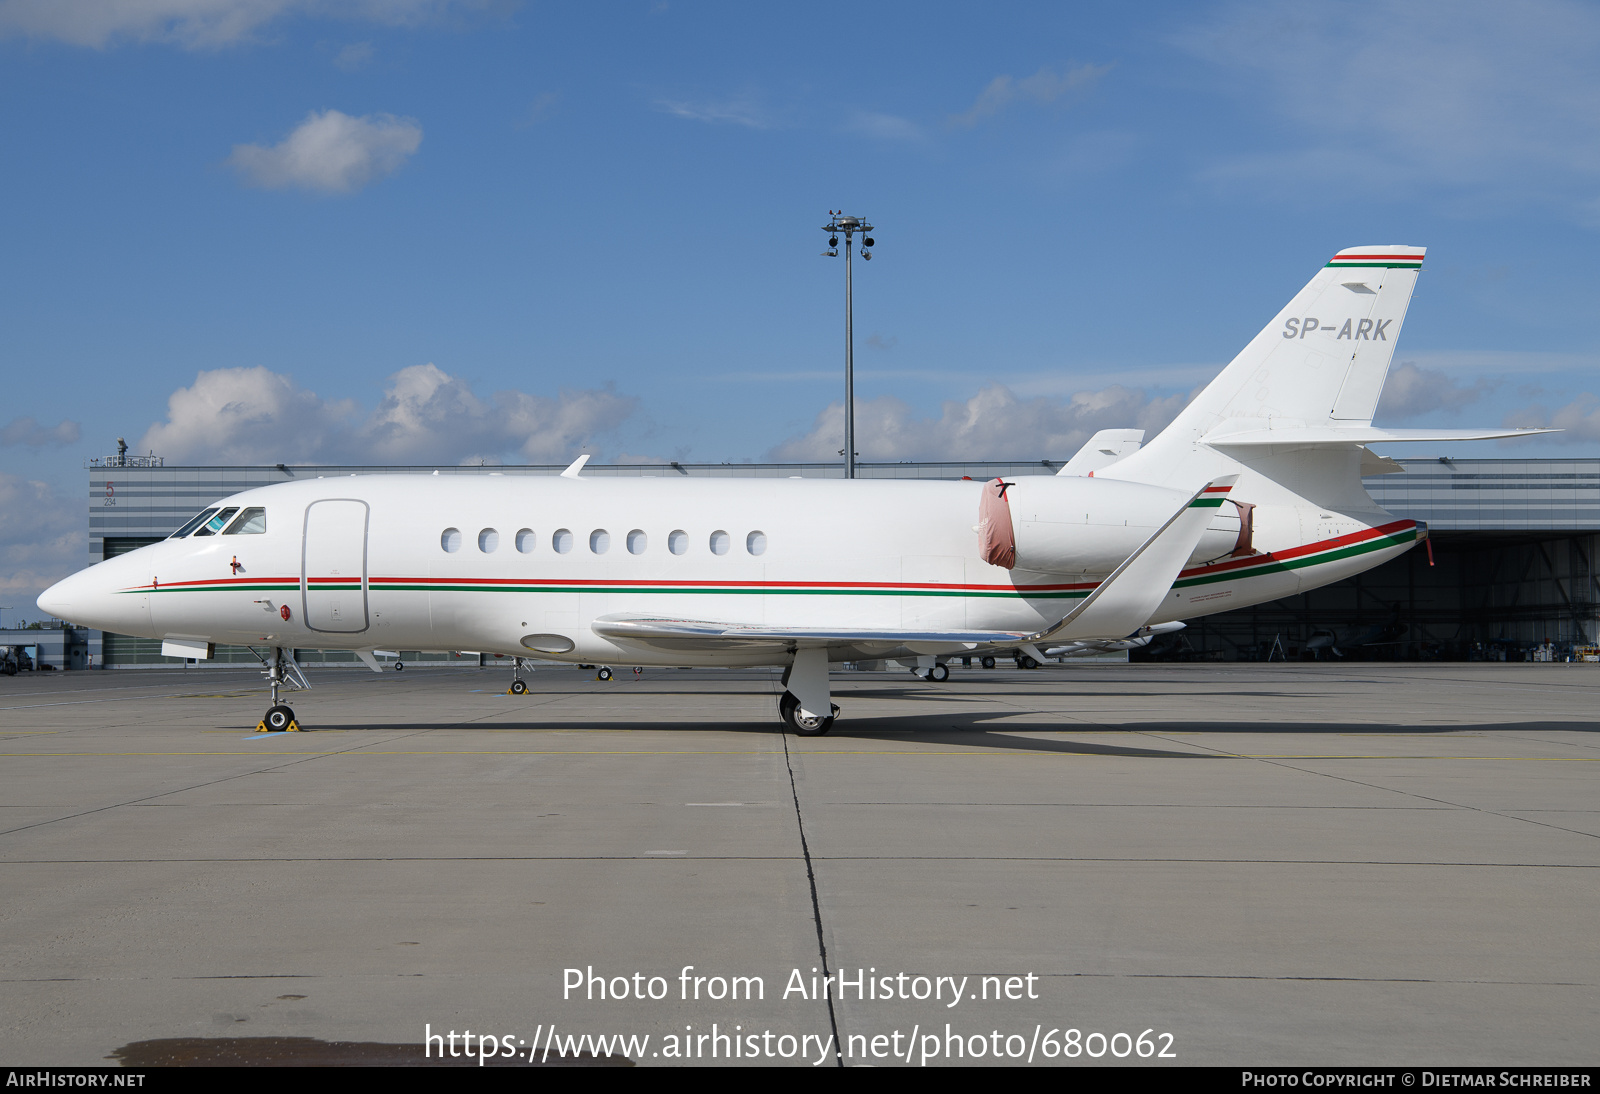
[138,365,637,464]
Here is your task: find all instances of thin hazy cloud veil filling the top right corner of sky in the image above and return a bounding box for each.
[1179,0,1600,221]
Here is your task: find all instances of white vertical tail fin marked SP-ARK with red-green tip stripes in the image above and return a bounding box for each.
[1106,246,1426,481]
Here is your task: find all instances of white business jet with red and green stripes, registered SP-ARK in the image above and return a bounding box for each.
[38,246,1539,736]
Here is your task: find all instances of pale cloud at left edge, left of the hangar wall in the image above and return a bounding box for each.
[0,472,90,610]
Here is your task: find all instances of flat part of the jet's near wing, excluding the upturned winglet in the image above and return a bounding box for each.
[594,614,1027,653]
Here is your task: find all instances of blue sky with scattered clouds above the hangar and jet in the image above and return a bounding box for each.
[0,0,1600,607]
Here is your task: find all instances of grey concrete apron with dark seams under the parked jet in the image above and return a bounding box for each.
[0,664,1600,1067]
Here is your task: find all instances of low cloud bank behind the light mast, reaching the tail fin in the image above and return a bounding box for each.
[771,384,1189,461]
